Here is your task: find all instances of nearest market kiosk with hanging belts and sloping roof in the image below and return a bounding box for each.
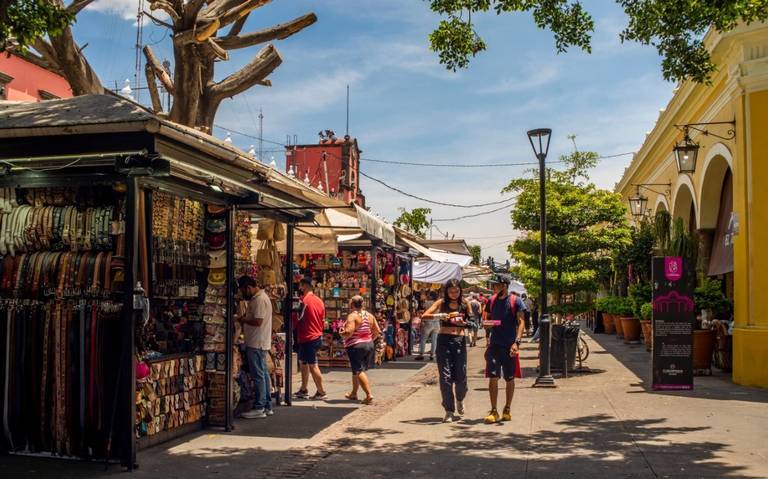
[0,96,328,469]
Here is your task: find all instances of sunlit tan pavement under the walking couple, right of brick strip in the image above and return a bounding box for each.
[306,335,768,478]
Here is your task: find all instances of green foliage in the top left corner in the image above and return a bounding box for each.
[0,0,74,52]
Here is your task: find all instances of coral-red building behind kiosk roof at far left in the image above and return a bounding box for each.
[0,53,72,101]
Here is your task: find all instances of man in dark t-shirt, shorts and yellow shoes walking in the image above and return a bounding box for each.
[484,276,525,424]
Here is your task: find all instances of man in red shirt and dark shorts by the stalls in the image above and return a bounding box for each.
[295,277,328,400]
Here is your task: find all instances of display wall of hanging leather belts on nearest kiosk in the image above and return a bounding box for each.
[0,185,125,458]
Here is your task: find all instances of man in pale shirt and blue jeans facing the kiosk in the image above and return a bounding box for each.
[236,276,274,419]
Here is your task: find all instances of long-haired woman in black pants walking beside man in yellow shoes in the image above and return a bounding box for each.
[423,279,471,422]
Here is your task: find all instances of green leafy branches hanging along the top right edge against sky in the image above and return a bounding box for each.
[428,0,768,82]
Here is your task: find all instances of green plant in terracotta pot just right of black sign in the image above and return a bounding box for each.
[693,278,730,374]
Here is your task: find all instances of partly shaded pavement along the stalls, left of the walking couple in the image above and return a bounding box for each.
[0,359,432,479]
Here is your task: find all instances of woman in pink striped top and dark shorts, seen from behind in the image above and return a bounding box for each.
[341,296,381,404]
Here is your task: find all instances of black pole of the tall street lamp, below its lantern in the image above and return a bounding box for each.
[534,153,555,387]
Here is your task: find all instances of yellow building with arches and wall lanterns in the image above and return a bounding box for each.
[616,23,768,387]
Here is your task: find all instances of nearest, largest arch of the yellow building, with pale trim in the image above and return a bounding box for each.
[697,143,733,229]
